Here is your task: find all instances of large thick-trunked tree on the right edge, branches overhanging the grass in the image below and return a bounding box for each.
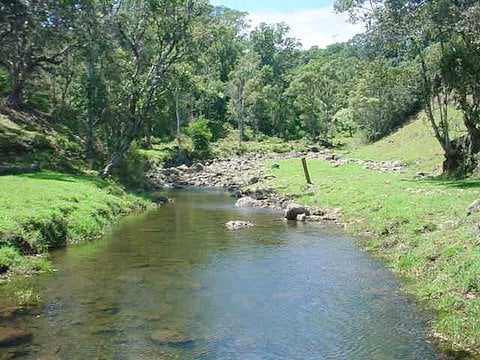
[336,0,480,173]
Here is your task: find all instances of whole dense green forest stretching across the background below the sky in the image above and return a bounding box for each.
[0,0,480,177]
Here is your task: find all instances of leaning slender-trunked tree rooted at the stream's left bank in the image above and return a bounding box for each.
[100,0,205,177]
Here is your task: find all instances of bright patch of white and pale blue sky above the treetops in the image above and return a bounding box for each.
[210,0,364,49]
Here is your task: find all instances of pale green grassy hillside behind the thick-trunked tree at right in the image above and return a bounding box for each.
[348,108,463,171]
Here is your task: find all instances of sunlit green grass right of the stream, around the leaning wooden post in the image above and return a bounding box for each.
[267,159,480,350]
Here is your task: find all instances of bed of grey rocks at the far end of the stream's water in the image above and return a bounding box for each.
[147,148,405,224]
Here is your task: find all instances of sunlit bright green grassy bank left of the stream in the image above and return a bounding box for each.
[0,171,147,273]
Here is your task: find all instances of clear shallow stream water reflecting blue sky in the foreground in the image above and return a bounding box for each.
[0,191,436,360]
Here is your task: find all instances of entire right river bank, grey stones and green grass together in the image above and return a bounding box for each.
[149,151,480,356]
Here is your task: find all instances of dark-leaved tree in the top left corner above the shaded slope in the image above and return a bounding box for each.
[0,0,78,108]
